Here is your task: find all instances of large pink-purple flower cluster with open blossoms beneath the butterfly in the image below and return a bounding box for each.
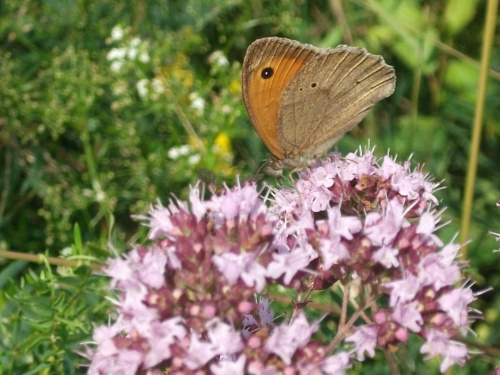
[88,149,478,375]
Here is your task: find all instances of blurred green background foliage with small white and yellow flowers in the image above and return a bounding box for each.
[0,0,500,374]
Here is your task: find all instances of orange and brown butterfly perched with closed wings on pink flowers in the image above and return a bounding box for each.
[242,37,396,176]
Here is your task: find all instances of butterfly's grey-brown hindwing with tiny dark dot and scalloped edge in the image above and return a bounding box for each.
[278,45,396,156]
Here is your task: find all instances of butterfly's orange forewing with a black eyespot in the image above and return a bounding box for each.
[242,37,322,159]
